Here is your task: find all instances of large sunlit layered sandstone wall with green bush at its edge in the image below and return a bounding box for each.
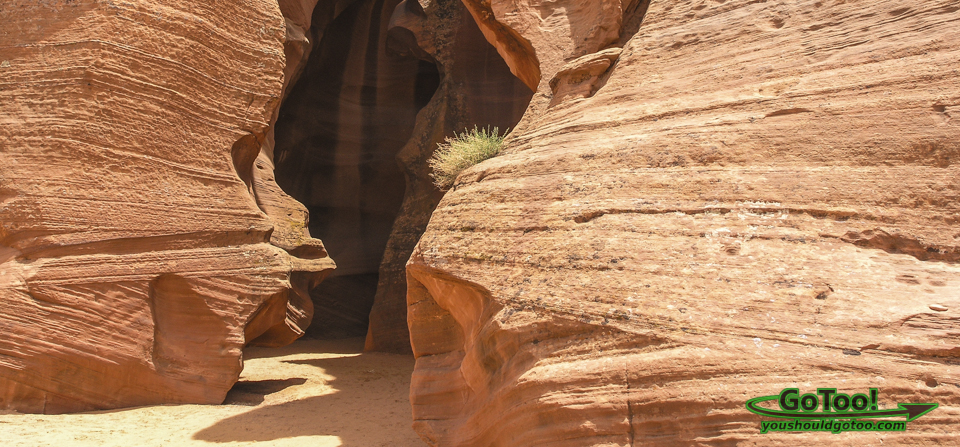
[407,0,960,446]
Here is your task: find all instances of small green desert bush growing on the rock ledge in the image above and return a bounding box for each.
[429,126,509,190]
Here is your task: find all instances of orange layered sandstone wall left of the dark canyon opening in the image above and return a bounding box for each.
[0,0,333,413]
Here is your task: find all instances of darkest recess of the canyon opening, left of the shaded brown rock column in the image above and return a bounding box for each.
[274,0,439,338]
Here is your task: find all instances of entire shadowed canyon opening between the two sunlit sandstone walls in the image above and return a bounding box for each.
[266,0,532,346]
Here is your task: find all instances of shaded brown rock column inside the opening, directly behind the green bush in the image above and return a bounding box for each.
[366,0,533,352]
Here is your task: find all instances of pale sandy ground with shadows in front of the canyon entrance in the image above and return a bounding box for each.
[0,339,425,447]
